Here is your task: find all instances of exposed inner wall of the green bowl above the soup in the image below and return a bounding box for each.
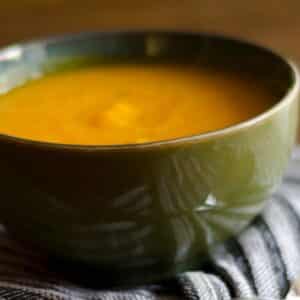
[0,32,296,147]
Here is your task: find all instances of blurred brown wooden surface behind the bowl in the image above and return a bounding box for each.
[0,0,300,140]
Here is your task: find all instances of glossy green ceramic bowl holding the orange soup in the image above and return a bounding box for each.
[0,32,299,284]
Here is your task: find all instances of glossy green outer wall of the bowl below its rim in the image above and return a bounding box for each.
[0,32,298,282]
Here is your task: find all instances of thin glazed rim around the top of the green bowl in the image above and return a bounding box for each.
[0,30,300,151]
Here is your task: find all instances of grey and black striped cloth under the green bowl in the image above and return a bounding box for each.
[0,148,300,300]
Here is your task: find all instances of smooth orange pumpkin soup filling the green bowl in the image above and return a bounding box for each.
[0,64,273,145]
